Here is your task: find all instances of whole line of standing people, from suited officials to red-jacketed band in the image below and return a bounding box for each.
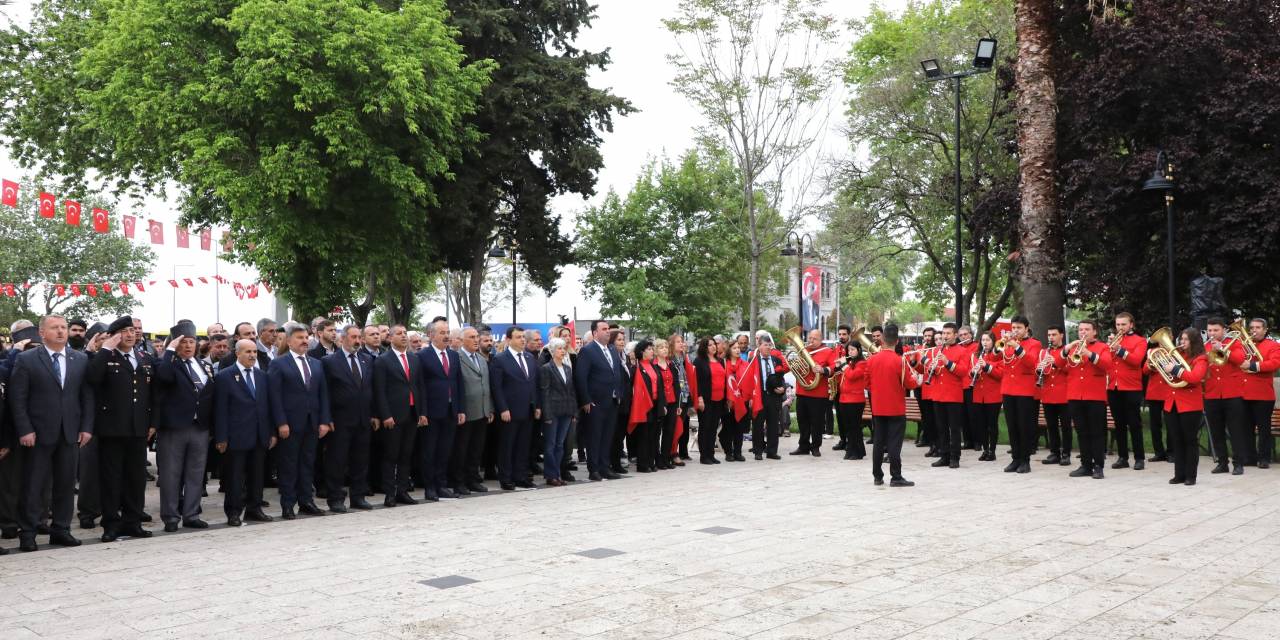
[0,314,1280,554]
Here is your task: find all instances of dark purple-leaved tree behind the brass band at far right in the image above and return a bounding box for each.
[1053,0,1280,332]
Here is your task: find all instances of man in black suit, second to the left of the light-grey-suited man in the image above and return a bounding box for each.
[365,324,426,507]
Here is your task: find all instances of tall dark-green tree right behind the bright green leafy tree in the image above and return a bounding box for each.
[430,0,634,324]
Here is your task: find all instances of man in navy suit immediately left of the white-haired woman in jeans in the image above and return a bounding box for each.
[489,325,541,492]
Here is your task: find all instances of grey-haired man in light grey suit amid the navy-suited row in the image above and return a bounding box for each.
[449,326,493,495]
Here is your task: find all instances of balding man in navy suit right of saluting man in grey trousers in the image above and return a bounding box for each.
[214,339,276,526]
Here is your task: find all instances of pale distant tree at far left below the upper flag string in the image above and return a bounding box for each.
[0,186,155,324]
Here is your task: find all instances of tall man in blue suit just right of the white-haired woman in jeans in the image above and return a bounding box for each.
[573,320,626,480]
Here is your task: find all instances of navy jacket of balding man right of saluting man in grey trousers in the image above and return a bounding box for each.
[214,366,275,451]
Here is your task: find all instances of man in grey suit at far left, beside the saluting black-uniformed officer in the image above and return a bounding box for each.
[9,316,93,552]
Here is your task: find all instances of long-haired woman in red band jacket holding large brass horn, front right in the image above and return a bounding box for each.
[1164,329,1208,486]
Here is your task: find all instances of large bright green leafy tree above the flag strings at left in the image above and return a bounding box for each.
[0,0,492,325]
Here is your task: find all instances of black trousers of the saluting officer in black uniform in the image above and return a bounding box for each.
[95,435,147,531]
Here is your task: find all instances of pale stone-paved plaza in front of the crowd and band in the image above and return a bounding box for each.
[0,439,1280,640]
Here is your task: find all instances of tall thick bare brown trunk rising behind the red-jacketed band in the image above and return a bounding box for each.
[1014,0,1066,339]
